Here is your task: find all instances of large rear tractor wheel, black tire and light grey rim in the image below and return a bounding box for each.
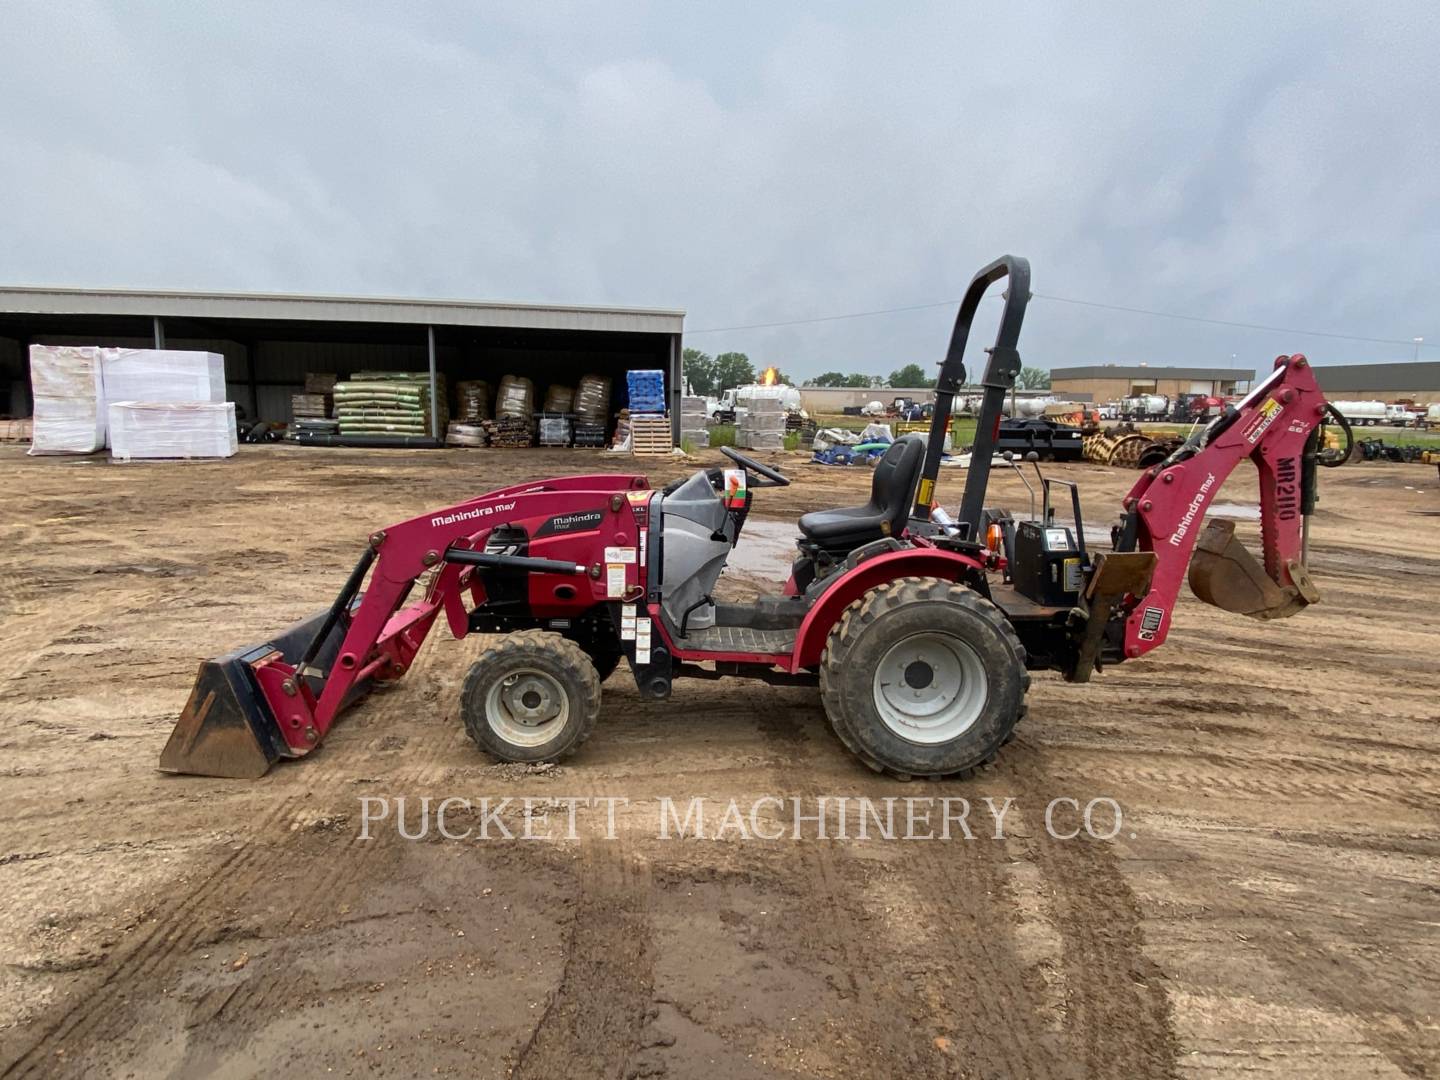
[819,577,1030,779]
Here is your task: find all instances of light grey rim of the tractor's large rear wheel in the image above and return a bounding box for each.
[873,631,989,746]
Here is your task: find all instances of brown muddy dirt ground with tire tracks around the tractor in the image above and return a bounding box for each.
[0,446,1440,1080]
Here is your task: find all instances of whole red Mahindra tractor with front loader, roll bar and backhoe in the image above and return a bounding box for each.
[160,263,1348,778]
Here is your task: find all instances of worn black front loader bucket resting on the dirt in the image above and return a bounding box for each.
[160,611,369,779]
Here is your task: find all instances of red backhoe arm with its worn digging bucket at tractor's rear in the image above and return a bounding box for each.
[1117,354,1326,658]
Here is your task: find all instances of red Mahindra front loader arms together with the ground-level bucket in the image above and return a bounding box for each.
[160,475,649,778]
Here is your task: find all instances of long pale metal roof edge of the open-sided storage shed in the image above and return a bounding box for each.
[0,285,685,334]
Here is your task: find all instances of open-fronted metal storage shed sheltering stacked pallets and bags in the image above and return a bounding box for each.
[0,288,684,440]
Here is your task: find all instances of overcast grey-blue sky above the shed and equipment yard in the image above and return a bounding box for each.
[0,0,1440,377]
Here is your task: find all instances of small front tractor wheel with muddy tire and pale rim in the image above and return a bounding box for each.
[459,631,600,762]
